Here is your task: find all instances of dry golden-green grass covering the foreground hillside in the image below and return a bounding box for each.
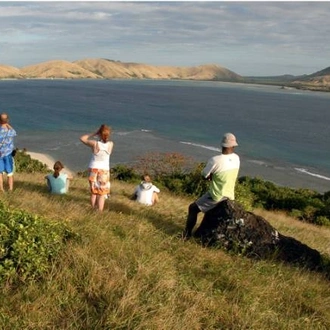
[0,156,330,330]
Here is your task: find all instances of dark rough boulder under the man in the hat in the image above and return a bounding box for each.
[194,200,324,271]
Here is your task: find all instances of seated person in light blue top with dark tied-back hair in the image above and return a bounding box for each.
[45,160,72,195]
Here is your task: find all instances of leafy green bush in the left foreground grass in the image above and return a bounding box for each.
[0,203,74,282]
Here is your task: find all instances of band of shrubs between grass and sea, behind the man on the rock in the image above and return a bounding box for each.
[114,153,330,225]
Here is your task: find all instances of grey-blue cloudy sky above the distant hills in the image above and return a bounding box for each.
[0,1,330,76]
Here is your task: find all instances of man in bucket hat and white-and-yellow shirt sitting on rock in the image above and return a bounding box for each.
[182,133,240,240]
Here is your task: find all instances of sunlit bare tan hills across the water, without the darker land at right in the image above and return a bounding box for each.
[0,59,244,82]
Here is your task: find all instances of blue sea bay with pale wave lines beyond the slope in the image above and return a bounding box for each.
[0,79,330,192]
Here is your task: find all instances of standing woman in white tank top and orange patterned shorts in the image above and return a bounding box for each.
[80,124,113,211]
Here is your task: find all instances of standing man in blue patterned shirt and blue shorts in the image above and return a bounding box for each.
[0,113,16,191]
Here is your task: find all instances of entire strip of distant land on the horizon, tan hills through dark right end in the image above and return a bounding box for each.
[0,58,330,91]
